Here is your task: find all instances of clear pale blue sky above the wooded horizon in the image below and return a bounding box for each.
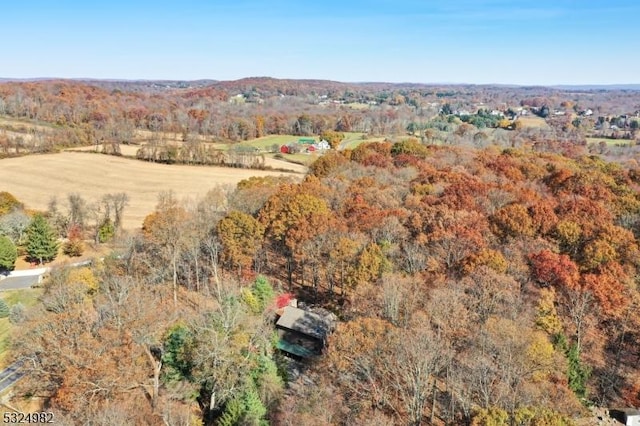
[0,0,640,85]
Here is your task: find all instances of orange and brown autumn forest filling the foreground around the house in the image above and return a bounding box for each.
[1,145,640,424]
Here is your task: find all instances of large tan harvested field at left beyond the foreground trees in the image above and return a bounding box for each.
[0,152,302,229]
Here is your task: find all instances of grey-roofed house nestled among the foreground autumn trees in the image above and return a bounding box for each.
[276,306,333,359]
